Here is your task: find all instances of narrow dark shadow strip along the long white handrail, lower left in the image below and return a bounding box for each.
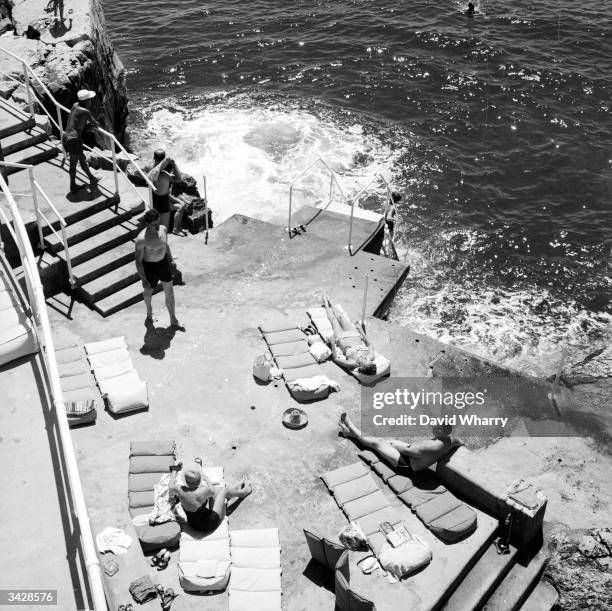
[30,357,91,609]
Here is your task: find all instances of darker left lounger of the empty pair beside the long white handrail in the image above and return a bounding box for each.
[55,345,101,427]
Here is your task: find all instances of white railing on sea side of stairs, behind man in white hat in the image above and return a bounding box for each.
[0,47,155,207]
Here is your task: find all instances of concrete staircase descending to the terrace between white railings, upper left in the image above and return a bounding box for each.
[0,100,148,316]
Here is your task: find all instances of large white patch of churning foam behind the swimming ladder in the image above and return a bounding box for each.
[137,100,394,223]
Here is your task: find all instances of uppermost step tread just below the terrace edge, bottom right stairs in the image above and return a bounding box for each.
[442,544,517,611]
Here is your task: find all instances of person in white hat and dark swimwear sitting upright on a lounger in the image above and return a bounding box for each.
[170,464,253,532]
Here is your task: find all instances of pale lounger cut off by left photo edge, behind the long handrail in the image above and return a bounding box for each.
[0,266,38,366]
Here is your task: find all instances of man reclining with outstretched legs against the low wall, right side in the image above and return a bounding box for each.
[338,414,463,471]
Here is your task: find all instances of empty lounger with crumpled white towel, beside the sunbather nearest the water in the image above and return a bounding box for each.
[259,321,337,401]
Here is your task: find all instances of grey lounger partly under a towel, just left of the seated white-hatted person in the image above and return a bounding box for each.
[128,440,181,551]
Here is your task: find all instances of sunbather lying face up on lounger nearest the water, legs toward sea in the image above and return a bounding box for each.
[323,295,376,375]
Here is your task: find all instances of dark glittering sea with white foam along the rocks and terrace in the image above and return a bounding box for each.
[103,0,612,375]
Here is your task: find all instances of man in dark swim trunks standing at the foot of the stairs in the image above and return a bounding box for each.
[136,210,185,331]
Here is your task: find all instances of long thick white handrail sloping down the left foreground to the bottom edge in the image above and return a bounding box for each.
[0,174,108,611]
